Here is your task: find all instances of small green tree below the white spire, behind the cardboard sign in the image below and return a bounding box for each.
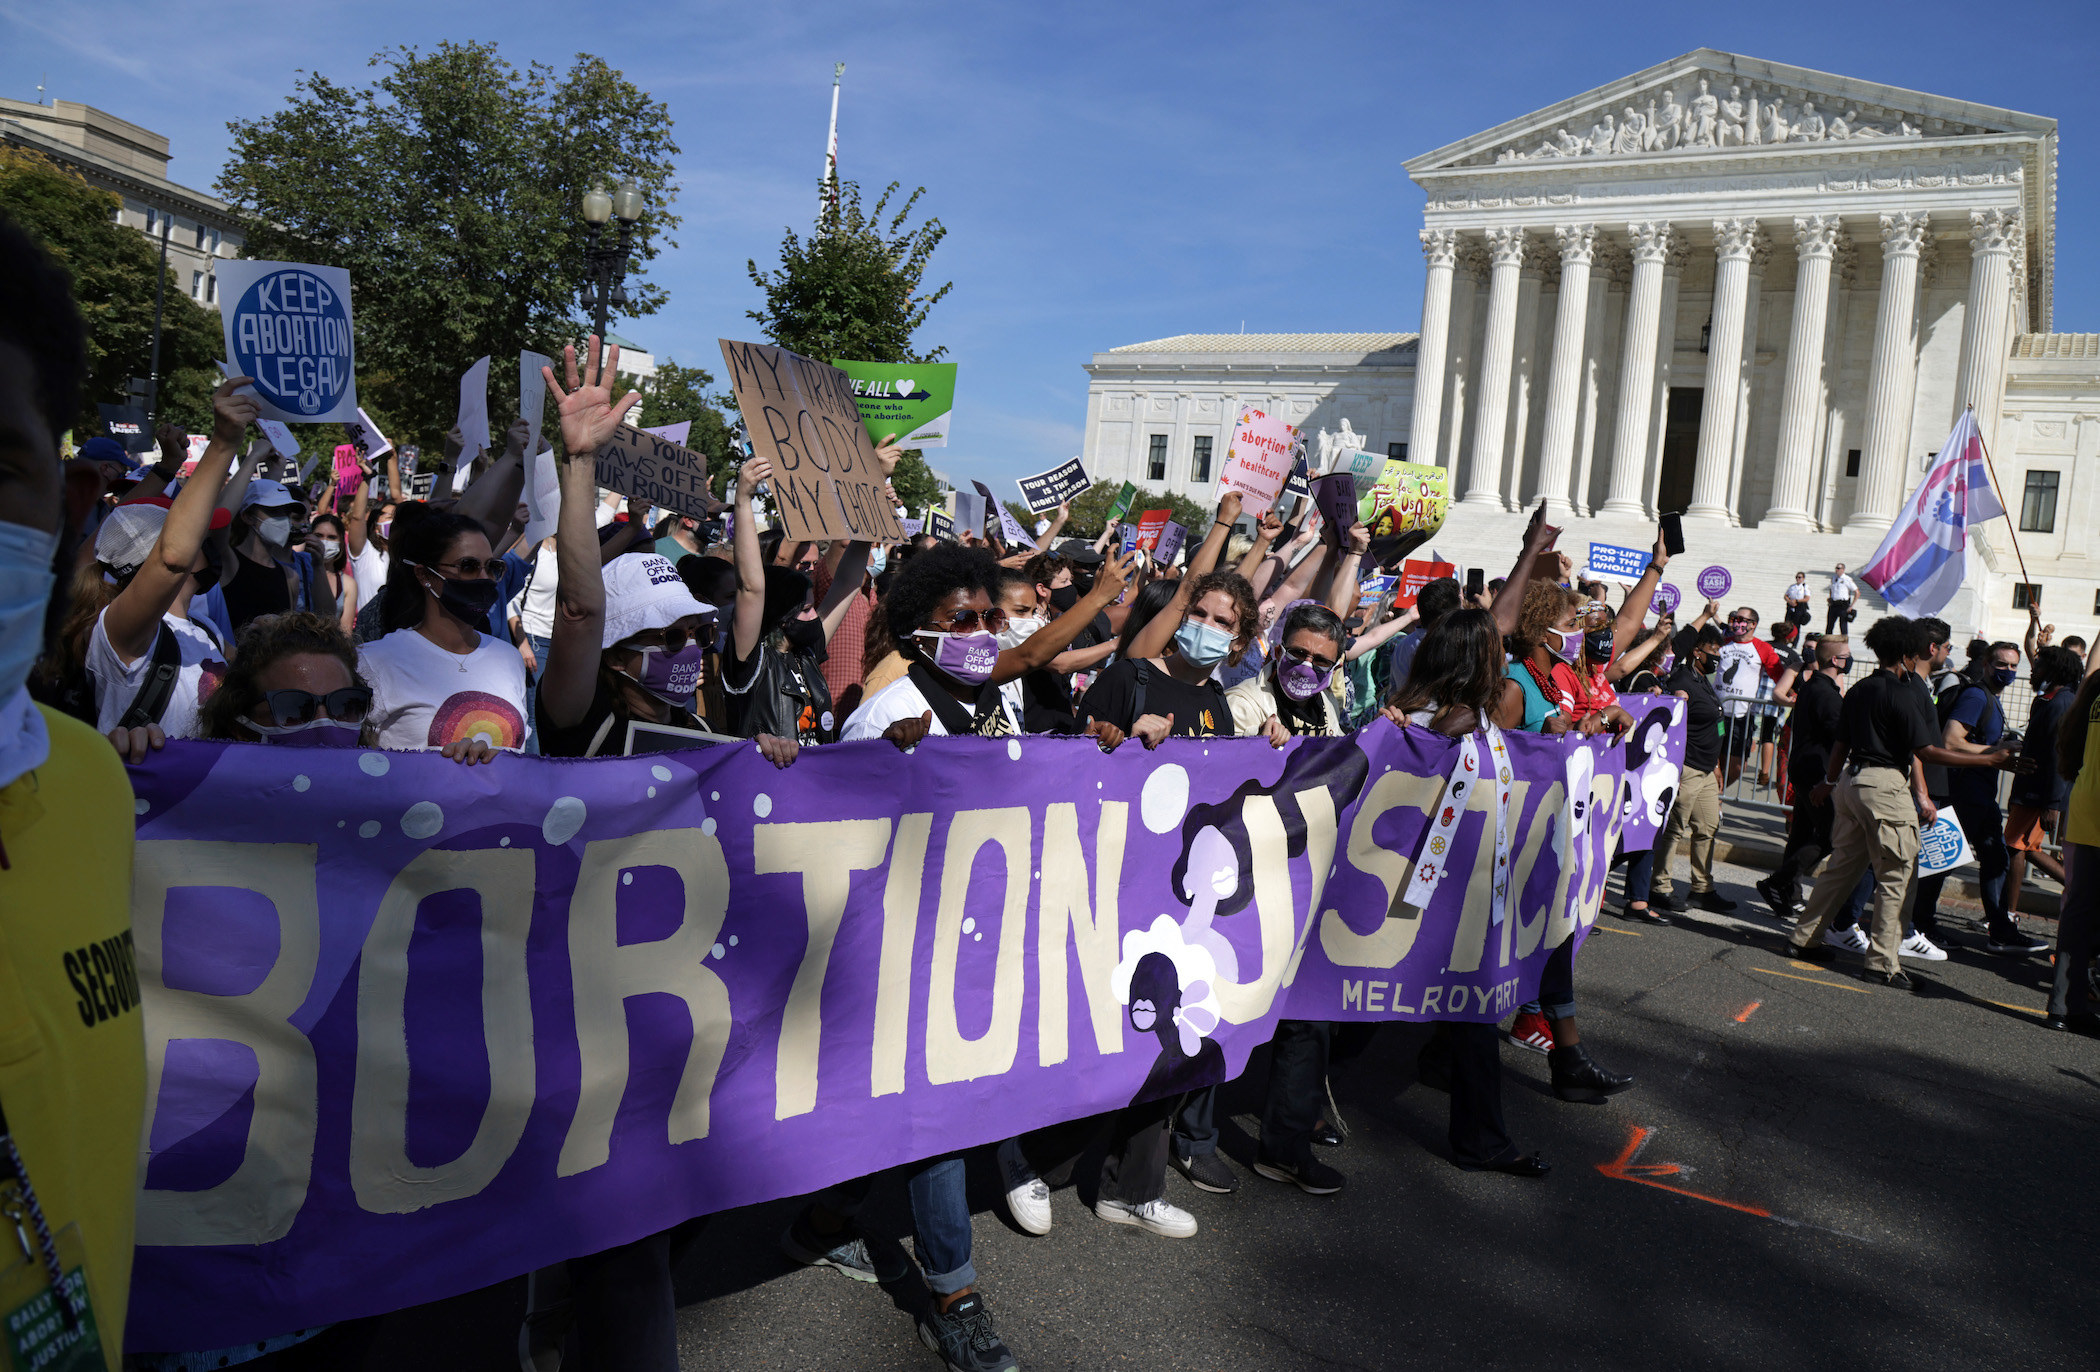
[746,181,953,361]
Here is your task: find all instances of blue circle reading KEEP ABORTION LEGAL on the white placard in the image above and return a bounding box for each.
[231,267,357,418]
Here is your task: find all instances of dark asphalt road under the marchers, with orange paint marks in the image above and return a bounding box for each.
[368,868,2100,1372]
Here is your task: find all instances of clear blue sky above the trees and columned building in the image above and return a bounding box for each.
[0,0,2100,491]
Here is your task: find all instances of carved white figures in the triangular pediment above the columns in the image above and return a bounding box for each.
[1493,76,1940,164]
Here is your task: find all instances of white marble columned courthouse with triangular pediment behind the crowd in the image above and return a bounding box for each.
[1084,48,2100,641]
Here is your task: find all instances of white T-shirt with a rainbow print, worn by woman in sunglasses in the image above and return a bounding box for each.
[357,628,529,752]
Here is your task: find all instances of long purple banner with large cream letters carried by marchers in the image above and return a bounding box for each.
[126,722,1682,1351]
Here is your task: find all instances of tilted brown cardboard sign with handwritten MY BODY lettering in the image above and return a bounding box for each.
[720,338,905,542]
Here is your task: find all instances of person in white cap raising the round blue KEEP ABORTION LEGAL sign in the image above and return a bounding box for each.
[40,380,258,763]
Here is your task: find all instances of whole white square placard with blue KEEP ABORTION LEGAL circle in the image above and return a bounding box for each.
[218,258,357,424]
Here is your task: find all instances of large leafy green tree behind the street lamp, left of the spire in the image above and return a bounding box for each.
[218,42,678,448]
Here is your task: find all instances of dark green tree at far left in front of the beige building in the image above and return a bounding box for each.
[0,147,223,432]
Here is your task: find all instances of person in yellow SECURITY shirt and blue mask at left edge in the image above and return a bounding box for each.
[0,219,154,1368]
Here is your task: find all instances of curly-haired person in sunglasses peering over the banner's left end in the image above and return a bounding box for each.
[197,609,376,748]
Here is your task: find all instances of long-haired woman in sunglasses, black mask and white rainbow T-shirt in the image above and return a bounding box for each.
[359,500,527,763]
